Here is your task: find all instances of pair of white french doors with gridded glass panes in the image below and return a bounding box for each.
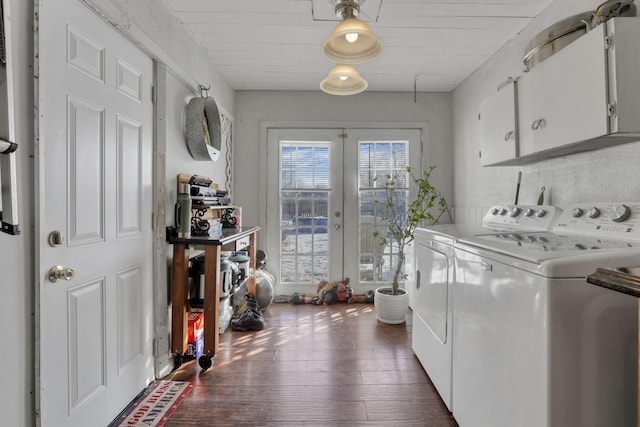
[266,128,422,295]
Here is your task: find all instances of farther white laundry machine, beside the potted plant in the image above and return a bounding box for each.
[411,206,560,412]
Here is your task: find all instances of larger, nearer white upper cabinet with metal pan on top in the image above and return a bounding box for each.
[482,17,640,166]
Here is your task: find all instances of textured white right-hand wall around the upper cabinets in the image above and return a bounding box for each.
[453,0,640,222]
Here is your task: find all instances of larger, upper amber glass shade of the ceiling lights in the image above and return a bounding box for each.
[322,18,382,64]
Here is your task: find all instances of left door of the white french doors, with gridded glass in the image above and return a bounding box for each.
[267,129,343,294]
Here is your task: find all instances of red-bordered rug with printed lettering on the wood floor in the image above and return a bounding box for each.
[109,381,193,427]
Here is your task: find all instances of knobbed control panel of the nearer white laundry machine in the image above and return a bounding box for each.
[553,202,640,239]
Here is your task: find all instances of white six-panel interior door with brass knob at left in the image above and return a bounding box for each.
[36,0,153,427]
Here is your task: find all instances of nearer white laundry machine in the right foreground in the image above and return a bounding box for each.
[452,203,640,427]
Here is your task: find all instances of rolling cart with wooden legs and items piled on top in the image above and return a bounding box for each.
[166,174,252,371]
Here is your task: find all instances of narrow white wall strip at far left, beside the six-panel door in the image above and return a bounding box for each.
[0,0,35,426]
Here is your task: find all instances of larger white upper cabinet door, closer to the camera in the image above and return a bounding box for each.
[520,25,609,156]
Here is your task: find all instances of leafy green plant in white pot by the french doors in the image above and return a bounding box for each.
[374,166,452,324]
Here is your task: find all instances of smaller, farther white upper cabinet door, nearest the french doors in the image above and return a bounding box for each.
[480,82,518,166]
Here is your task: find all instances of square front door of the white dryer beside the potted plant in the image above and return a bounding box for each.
[413,240,453,344]
